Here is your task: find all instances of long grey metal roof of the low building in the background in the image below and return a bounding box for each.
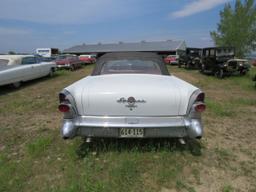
[63,40,186,55]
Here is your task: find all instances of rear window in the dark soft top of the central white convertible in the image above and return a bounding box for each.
[101,60,161,74]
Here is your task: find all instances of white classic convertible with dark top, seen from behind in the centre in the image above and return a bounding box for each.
[59,52,205,139]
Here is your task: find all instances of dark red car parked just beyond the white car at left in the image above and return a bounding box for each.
[55,55,82,71]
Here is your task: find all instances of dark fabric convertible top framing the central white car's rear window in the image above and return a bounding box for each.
[91,52,170,76]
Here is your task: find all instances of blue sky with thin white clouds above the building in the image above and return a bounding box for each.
[0,0,234,53]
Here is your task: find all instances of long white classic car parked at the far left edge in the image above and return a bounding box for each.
[0,55,56,87]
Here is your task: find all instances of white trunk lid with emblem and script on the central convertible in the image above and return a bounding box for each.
[81,74,181,116]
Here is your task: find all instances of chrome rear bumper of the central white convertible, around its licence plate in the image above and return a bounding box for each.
[61,116,203,139]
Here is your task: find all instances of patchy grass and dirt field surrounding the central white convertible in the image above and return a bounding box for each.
[0,65,256,192]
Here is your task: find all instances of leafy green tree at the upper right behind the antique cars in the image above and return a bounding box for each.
[210,0,256,57]
